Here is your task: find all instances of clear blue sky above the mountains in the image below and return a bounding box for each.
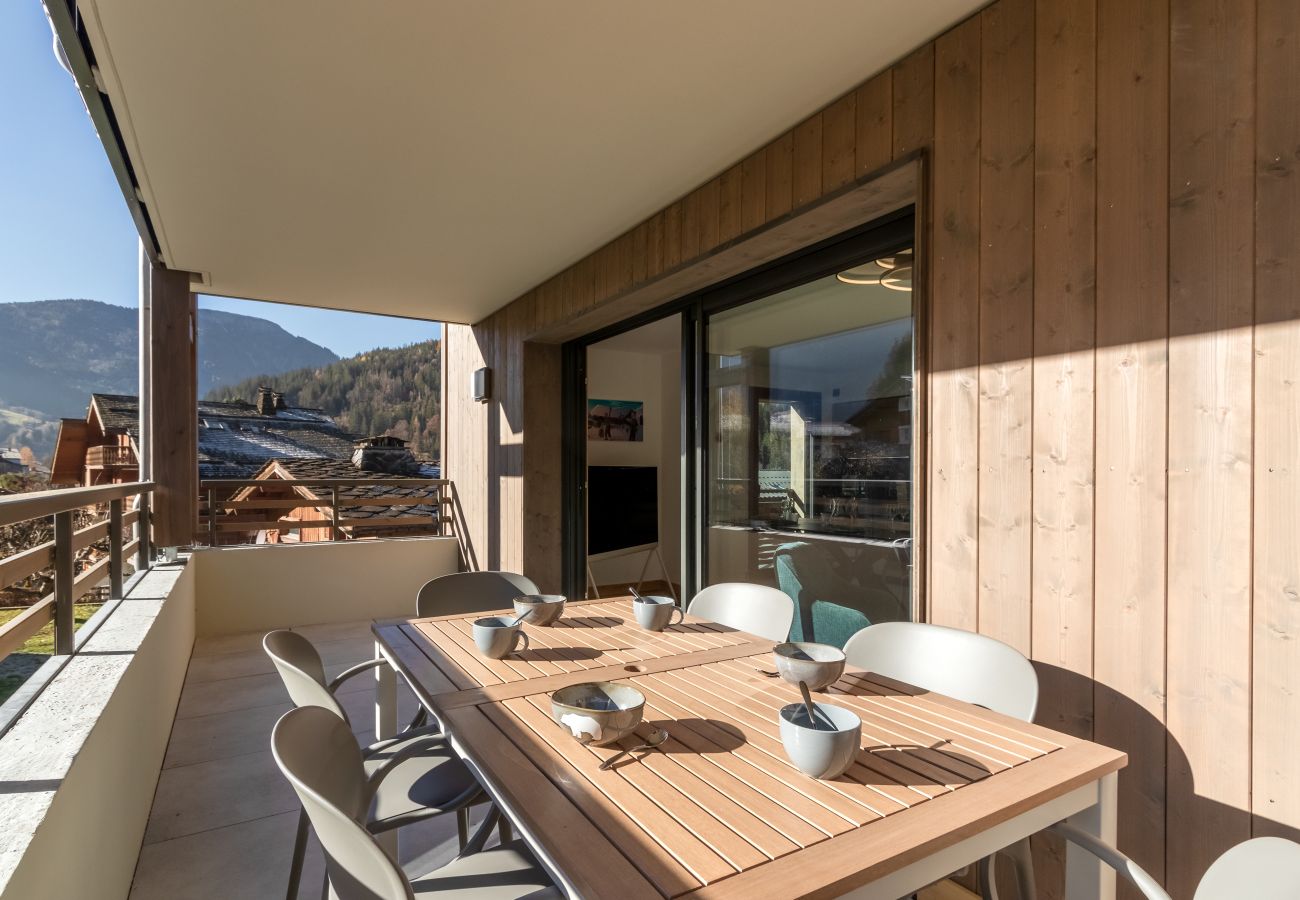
[0,0,438,356]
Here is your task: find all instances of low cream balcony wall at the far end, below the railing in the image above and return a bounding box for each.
[194,537,459,637]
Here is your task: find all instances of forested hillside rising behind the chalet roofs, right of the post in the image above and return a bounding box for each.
[207,341,442,459]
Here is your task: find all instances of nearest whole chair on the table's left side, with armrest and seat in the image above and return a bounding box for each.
[270,706,562,900]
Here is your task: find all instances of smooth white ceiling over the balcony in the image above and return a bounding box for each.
[79,0,983,321]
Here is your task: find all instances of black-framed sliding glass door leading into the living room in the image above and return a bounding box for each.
[564,213,917,644]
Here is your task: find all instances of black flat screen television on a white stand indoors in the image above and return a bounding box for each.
[586,466,659,554]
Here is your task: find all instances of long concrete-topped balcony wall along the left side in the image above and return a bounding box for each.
[0,561,195,900]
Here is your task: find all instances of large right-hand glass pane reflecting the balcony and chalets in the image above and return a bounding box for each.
[706,251,913,645]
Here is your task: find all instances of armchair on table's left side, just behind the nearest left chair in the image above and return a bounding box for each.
[261,631,486,900]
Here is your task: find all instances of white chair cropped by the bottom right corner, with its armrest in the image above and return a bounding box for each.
[1050,822,1300,900]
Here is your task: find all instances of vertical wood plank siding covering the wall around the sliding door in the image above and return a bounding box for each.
[445,0,1300,896]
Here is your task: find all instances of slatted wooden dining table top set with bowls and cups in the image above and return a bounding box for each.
[373,597,1126,900]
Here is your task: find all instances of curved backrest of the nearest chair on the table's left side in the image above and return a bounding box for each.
[270,706,415,900]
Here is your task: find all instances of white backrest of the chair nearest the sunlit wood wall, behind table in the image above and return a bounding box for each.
[844,622,1039,722]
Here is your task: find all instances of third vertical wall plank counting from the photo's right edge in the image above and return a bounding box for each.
[1093,0,1169,896]
